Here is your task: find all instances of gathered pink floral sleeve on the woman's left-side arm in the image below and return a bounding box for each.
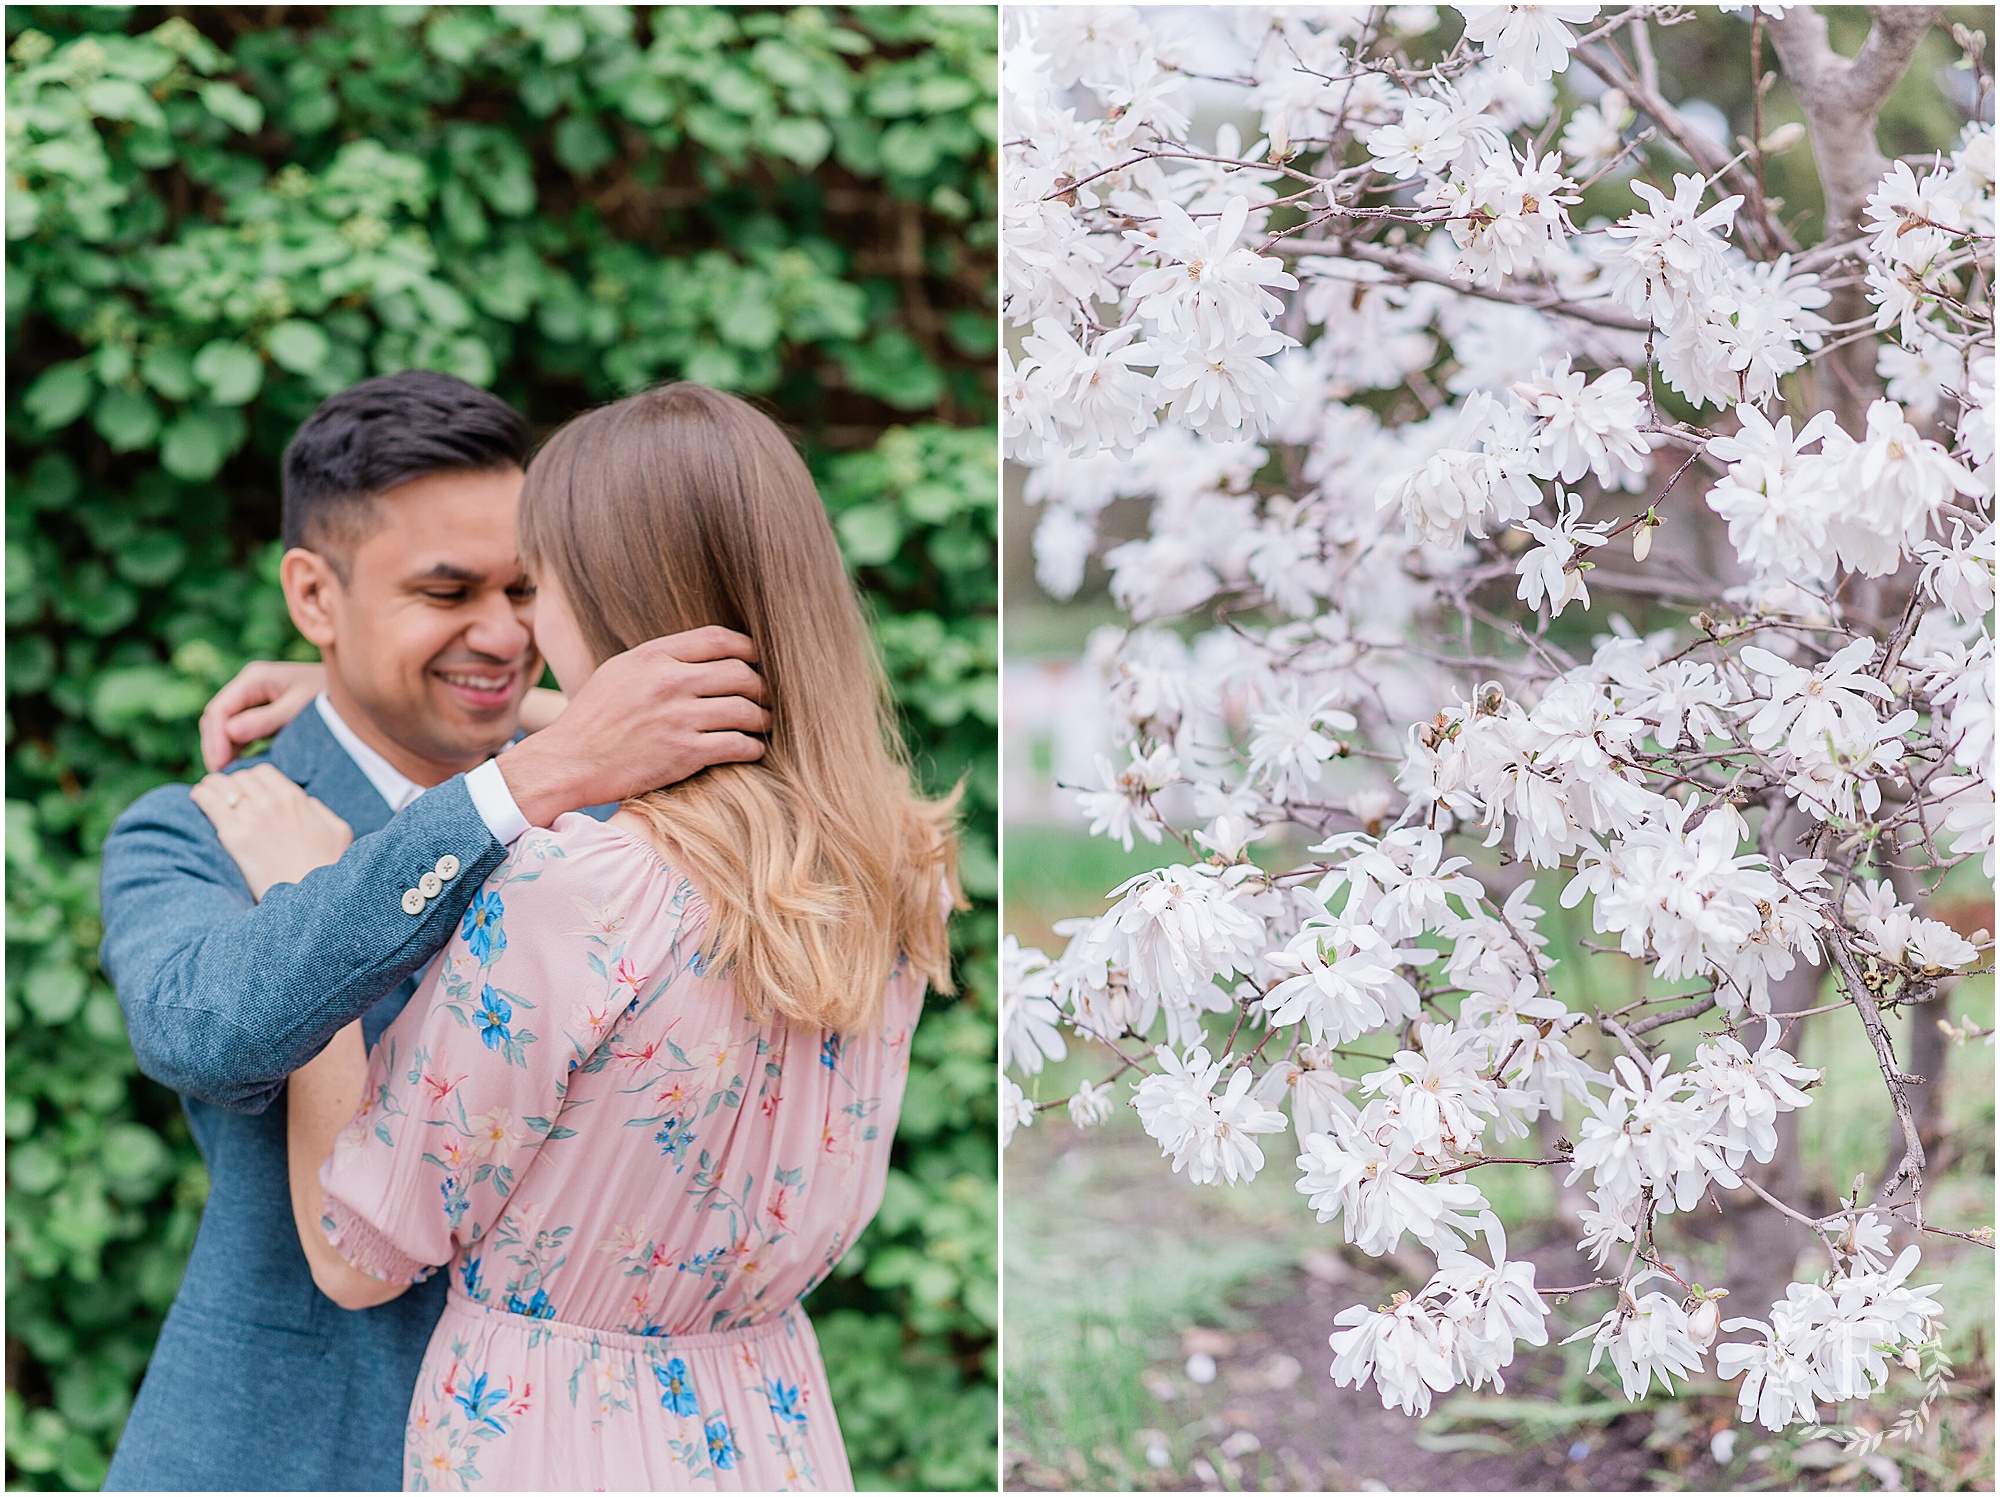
[320,833,678,1283]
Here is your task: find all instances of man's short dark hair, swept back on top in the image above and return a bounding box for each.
[284,368,530,566]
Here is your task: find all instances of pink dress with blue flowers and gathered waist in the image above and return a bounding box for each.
[320,815,924,1491]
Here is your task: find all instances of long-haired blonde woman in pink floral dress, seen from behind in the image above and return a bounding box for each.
[248,384,956,1491]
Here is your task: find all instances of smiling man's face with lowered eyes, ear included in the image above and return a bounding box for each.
[288,468,542,773]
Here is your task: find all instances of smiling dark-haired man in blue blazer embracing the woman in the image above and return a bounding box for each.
[102,372,768,1491]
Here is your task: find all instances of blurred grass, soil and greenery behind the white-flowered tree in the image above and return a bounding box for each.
[1002,6,1994,1491]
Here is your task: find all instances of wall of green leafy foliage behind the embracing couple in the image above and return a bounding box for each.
[6,6,998,1489]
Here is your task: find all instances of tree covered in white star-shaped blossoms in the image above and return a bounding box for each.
[1002,4,1994,1429]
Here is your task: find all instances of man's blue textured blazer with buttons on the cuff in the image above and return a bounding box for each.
[102,708,506,1491]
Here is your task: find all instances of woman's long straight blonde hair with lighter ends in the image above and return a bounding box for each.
[520,384,964,1033]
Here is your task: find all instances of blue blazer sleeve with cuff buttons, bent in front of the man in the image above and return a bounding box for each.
[100,777,506,1113]
